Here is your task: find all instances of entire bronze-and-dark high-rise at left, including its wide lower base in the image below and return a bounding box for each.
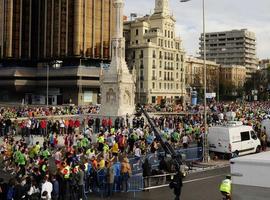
[0,0,115,104]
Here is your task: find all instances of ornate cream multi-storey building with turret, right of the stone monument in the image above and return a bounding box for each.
[124,0,185,103]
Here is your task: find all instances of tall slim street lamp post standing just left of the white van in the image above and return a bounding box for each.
[180,0,209,162]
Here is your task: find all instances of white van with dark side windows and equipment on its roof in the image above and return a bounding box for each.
[208,122,261,157]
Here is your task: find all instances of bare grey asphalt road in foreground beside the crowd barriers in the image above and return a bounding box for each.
[89,167,230,200]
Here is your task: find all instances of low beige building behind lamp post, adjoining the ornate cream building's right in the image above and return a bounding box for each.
[185,57,220,93]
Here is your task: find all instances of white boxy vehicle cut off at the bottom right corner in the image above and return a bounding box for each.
[230,152,270,200]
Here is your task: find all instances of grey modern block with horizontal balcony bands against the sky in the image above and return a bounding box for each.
[200,29,258,76]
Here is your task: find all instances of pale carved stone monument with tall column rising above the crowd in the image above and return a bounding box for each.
[100,0,136,117]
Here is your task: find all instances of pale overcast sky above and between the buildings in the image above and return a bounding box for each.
[125,0,270,59]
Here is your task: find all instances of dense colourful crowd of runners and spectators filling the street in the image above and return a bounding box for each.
[0,102,270,200]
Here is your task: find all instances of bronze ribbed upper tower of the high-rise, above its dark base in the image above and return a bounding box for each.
[0,0,114,60]
